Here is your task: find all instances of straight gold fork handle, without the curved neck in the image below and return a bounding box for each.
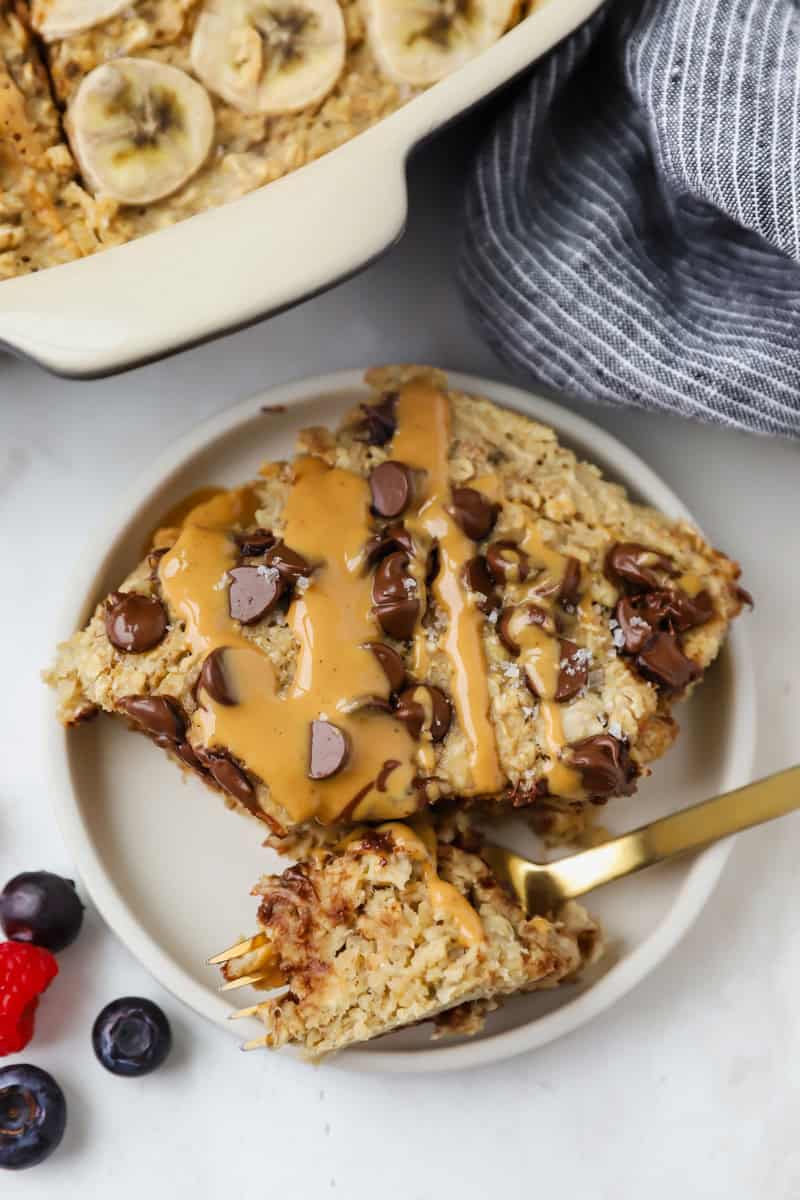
[552,767,800,899]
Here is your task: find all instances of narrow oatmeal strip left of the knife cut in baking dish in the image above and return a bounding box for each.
[0,0,95,280]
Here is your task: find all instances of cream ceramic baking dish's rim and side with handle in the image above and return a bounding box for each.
[0,0,601,378]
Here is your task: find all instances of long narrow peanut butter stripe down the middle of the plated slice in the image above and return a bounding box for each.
[392,382,504,796]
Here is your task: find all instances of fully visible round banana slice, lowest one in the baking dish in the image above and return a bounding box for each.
[65,59,213,204]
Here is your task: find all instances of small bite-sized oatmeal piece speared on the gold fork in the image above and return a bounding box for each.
[215,822,602,1058]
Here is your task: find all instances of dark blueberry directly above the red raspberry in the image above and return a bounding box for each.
[0,871,83,953]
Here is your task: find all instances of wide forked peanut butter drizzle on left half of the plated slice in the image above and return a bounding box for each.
[160,457,417,822]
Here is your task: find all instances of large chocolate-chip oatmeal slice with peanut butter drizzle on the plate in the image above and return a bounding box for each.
[48,367,744,853]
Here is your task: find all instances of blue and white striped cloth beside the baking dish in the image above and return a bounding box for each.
[462,0,800,437]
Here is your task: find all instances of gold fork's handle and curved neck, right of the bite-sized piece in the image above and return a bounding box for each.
[481,767,800,917]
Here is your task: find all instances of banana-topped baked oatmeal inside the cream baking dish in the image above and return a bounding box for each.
[0,0,536,275]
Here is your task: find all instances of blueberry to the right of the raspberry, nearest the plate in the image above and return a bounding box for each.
[91,996,173,1075]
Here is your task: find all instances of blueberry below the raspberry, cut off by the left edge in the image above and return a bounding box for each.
[0,1062,67,1170]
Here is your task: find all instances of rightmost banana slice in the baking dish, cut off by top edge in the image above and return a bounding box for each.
[367,0,517,88]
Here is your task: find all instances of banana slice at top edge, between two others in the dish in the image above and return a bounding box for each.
[192,0,345,115]
